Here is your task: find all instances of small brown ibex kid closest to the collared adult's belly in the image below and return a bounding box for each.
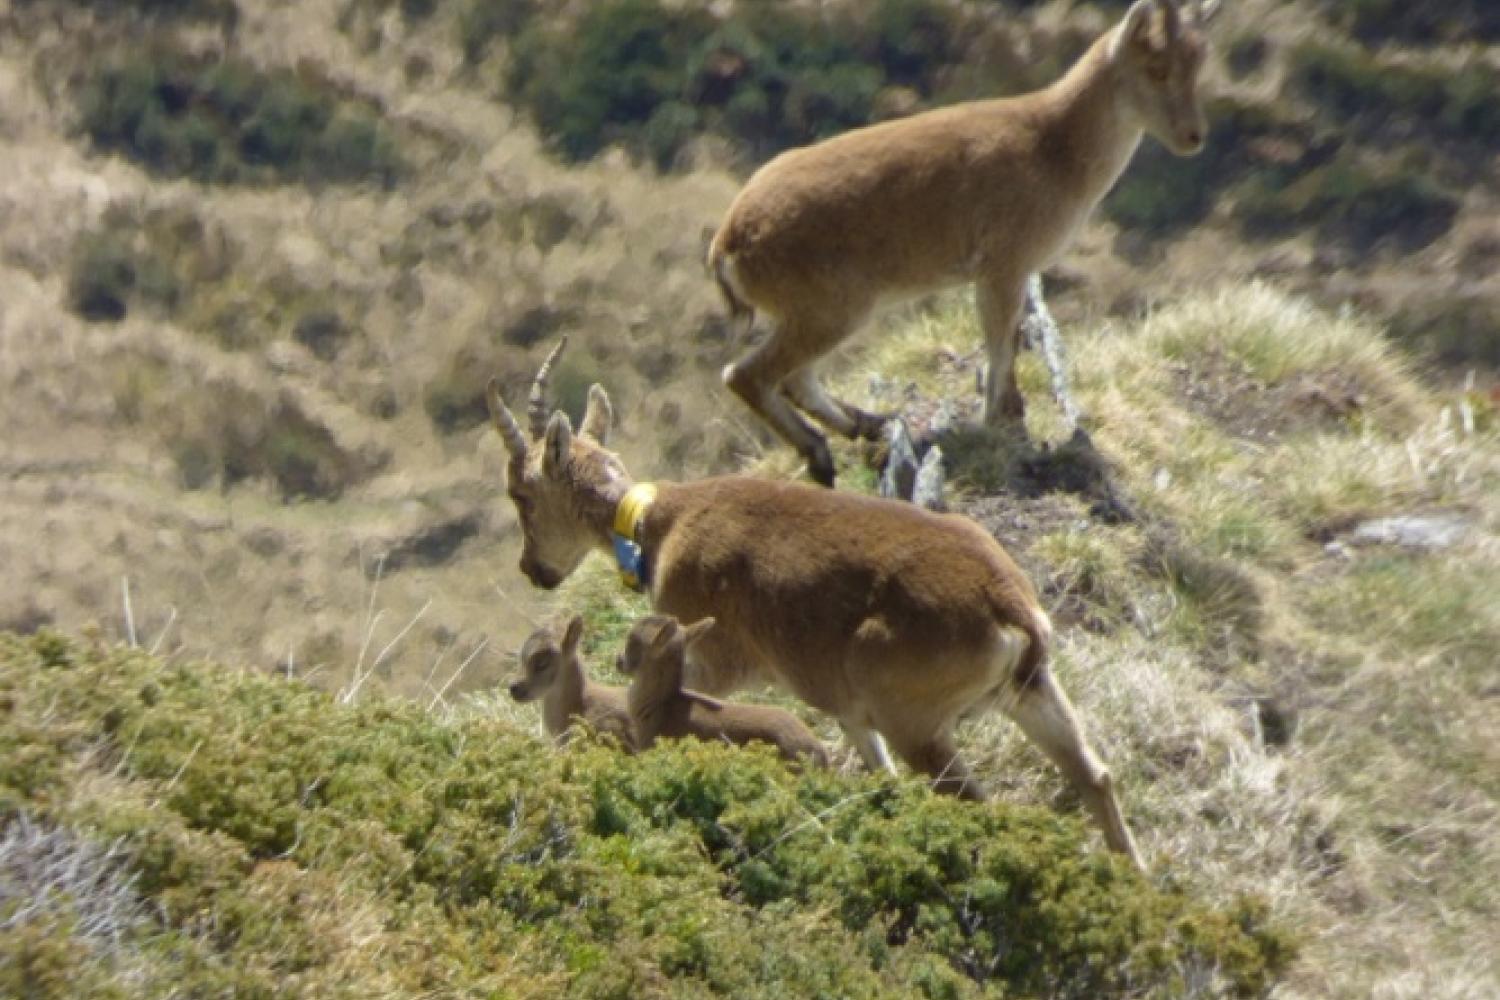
[618,615,828,766]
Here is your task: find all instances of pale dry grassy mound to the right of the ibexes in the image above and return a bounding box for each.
[696,285,1500,999]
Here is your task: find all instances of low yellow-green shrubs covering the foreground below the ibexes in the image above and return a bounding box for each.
[0,631,1290,997]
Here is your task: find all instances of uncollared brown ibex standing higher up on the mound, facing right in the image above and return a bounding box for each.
[708,0,1217,486]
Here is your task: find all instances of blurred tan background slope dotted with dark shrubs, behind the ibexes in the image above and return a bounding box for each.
[0,0,1500,699]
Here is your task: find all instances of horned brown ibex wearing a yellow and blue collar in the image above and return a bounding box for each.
[488,343,1140,865]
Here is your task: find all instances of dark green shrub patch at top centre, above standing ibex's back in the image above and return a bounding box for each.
[498,0,999,168]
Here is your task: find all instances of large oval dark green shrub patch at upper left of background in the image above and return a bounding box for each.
[80,51,402,186]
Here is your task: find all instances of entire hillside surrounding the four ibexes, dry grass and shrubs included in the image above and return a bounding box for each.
[0,0,1500,999]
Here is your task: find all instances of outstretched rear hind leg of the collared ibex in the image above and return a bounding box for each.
[1004,667,1143,868]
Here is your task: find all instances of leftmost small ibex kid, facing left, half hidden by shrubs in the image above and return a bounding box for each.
[510,615,636,750]
